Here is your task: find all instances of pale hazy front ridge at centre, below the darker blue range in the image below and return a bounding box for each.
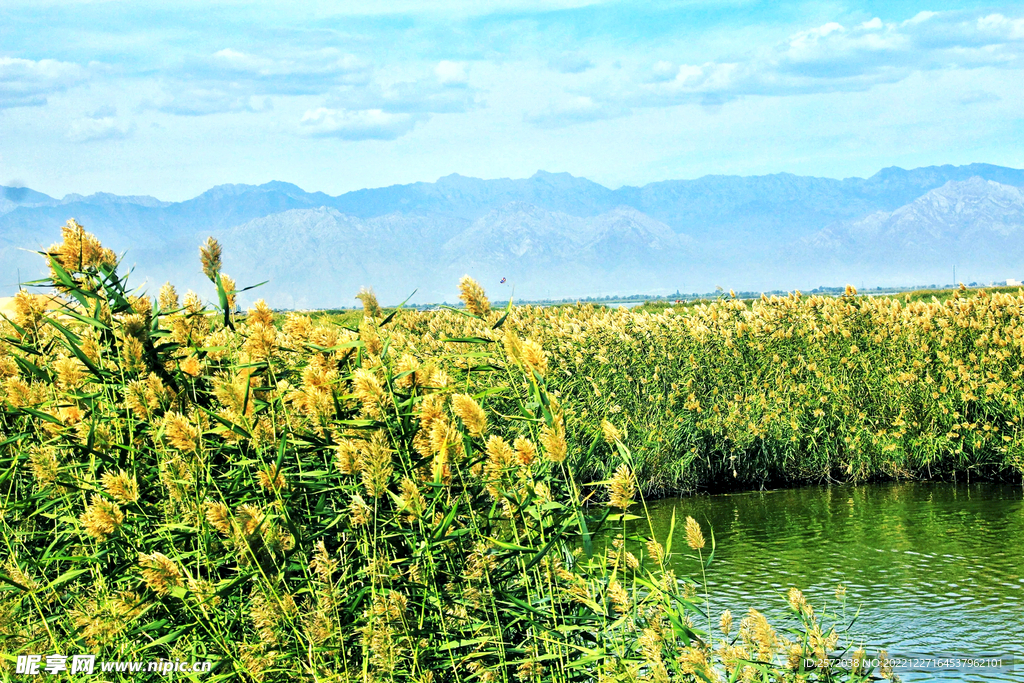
[223,202,689,307]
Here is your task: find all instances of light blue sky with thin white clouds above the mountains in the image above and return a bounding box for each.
[0,0,1024,201]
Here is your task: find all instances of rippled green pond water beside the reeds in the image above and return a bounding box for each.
[636,482,1024,681]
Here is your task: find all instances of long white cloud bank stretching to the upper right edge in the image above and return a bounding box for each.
[587,12,1024,106]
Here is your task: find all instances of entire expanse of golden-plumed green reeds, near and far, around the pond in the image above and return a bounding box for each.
[0,221,1024,683]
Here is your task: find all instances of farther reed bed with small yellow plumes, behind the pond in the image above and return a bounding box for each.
[362,287,1024,495]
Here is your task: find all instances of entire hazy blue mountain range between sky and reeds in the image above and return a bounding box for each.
[0,164,1024,307]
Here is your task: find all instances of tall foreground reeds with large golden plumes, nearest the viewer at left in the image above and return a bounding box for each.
[0,221,884,683]
